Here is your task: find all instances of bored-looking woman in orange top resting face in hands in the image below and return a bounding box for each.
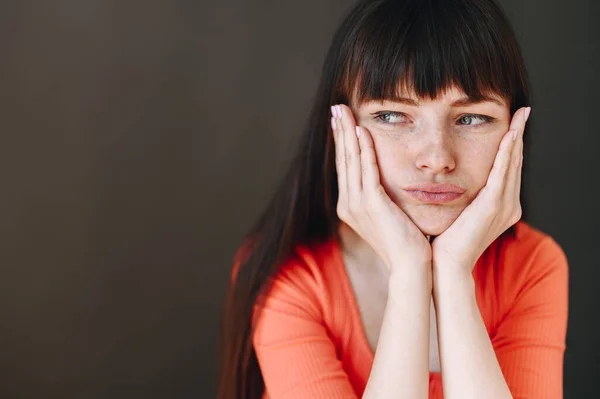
[219,0,568,399]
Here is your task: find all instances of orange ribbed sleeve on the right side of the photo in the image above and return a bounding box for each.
[492,236,568,399]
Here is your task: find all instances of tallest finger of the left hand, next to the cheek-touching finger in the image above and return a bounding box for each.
[338,104,362,198]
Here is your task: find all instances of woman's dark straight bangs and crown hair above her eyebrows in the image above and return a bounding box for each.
[338,0,525,110]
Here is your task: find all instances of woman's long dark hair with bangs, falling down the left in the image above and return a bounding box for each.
[218,0,530,399]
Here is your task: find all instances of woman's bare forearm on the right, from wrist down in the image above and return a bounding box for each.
[433,265,511,399]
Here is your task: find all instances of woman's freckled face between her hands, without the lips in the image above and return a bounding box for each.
[351,88,510,235]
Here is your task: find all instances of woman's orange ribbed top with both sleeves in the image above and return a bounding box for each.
[253,221,568,399]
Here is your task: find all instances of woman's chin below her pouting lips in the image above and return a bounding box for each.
[402,204,464,236]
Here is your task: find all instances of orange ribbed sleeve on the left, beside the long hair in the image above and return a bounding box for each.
[253,264,357,399]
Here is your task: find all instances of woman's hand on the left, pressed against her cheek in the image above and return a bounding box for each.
[331,104,432,270]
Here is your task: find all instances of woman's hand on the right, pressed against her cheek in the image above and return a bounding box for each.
[431,108,531,273]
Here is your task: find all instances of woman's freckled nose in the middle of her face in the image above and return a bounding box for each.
[416,129,456,175]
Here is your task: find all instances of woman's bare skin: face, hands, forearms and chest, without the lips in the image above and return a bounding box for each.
[332,89,529,398]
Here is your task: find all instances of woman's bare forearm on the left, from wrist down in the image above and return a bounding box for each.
[363,265,432,399]
